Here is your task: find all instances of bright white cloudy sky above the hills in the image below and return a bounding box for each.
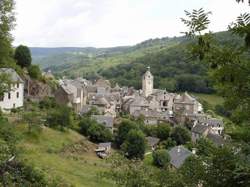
[13,0,250,47]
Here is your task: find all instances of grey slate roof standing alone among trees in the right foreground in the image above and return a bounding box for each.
[168,146,192,169]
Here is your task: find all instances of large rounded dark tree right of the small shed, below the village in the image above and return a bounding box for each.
[122,130,146,159]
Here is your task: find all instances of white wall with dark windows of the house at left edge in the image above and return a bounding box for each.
[0,83,24,111]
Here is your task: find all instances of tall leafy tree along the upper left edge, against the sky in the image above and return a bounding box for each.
[0,0,15,65]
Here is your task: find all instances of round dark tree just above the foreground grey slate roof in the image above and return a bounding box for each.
[171,126,191,145]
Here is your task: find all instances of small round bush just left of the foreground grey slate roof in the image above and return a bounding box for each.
[153,149,170,168]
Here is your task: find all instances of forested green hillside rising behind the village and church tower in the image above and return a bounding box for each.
[32,32,242,93]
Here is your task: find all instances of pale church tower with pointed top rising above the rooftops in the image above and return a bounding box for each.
[142,67,154,97]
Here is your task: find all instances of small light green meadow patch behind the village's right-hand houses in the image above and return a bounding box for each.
[192,93,224,107]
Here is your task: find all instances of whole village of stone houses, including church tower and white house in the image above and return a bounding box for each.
[0,67,226,168]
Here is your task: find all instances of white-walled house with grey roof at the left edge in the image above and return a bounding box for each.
[0,68,24,112]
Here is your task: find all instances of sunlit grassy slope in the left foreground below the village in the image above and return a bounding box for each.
[15,124,112,187]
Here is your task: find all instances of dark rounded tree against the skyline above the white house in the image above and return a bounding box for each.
[15,45,32,68]
